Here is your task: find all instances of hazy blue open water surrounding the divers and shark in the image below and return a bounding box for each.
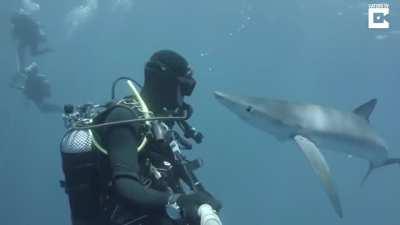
[0,0,400,225]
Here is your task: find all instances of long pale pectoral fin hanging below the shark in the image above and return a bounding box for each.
[294,135,343,218]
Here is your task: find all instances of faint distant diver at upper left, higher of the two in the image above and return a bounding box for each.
[10,9,52,72]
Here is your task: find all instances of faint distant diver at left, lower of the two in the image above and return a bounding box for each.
[11,62,63,113]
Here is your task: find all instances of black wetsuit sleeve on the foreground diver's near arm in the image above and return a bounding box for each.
[103,107,174,225]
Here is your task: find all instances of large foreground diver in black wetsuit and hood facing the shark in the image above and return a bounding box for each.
[60,50,222,225]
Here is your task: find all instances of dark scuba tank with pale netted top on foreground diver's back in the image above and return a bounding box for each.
[60,104,105,225]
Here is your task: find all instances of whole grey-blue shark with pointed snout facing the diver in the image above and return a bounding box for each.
[214,92,400,218]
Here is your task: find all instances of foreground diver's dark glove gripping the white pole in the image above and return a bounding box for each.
[176,192,222,221]
